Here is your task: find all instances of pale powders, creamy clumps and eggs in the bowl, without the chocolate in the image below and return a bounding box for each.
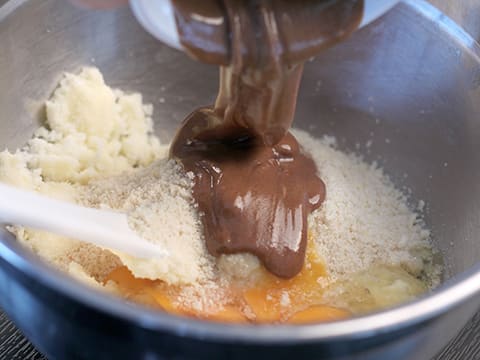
[0,68,440,323]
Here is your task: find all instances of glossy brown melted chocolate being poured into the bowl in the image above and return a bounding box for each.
[170,0,363,278]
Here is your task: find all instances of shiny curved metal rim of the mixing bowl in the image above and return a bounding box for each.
[0,0,480,345]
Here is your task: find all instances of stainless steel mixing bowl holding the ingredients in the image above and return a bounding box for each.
[0,0,480,360]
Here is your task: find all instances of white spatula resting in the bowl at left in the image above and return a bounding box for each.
[0,184,168,258]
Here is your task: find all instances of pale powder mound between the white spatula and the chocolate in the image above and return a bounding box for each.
[81,159,214,284]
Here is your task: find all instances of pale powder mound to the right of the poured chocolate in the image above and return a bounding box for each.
[294,130,438,284]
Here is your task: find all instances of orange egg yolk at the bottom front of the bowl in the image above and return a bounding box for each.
[106,239,351,324]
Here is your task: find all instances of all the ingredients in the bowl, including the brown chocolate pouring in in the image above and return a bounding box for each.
[0,0,440,323]
